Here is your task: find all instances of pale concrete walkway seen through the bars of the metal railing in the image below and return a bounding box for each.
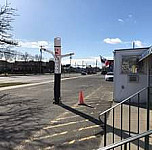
[101,103,152,150]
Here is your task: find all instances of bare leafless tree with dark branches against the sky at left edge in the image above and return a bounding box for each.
[0,3,17,74]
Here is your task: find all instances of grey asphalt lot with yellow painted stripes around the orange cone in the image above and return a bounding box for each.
[0,75,112,150]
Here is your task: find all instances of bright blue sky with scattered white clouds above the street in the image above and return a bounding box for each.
[0,0,152,67]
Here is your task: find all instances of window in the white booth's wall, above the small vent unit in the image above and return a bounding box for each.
[121,55,145,74]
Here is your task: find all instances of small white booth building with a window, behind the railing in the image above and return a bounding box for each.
[114,47,152,103]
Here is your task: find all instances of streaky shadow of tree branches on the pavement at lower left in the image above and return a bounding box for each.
[0,93,46,150]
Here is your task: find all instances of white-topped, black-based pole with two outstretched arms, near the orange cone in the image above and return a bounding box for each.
[41,37,74,104]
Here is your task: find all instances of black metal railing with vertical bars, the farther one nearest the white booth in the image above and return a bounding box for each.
[99,87,152,150]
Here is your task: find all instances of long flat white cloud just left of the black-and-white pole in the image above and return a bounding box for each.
[18,41,53,48]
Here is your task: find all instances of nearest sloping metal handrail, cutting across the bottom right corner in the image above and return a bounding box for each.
[98,130,152,150]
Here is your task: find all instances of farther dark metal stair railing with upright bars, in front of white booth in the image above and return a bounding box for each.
[99,87,150,150]
